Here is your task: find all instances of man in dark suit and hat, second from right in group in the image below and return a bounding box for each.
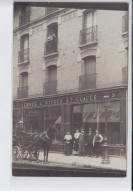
[86,128,94,157]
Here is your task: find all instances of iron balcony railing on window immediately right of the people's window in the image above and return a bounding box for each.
[80,26,97,44]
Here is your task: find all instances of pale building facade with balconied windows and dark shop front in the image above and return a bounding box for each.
[13,6,128,155]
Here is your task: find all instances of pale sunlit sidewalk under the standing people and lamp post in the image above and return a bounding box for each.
[39,152,126,171]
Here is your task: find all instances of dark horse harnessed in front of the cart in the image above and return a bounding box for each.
[33,125,56,163]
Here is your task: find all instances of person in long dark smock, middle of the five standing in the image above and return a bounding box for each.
[78,129,85,156]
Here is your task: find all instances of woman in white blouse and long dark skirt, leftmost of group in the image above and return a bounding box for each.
[64,132,72,156]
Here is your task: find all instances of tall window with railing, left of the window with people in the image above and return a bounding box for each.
[18,34,29,63]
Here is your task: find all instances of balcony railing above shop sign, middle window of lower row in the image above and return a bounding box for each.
[43,80,57,95]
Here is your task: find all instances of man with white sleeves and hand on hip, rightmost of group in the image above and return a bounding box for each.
[93,130,103,157]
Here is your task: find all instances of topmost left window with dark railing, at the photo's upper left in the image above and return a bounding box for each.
[19,6,30,26]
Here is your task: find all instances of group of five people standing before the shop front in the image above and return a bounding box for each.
[64,128,103,157]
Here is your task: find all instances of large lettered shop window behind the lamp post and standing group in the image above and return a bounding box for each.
[82,101,120,145]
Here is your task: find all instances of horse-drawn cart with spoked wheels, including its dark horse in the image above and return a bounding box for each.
[12,125,56,162]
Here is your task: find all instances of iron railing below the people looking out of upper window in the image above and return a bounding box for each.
[44,39,58,55]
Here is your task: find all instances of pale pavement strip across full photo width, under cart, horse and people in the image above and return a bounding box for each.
[13,151,126,171]
